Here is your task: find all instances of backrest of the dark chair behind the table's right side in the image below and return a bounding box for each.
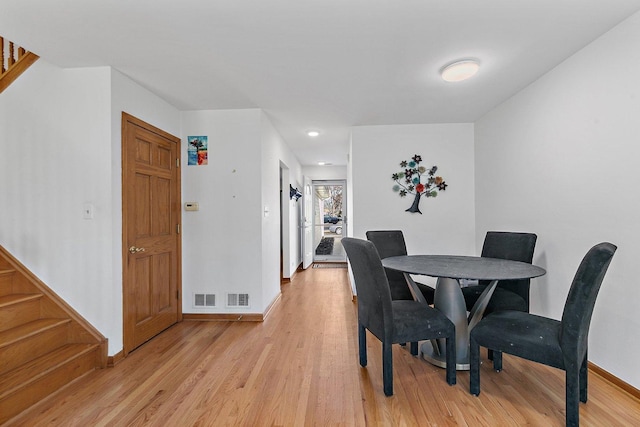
[480,231,538,308]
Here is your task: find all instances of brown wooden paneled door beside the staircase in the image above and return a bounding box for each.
[122,113,182,355]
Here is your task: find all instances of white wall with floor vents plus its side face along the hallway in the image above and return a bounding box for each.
[181,109,301,313]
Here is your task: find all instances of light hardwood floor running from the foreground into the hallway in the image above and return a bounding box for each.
[8,268,640,427]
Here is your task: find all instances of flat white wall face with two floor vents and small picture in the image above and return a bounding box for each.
[182,109,263,313]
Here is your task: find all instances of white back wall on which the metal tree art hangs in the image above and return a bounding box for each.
[349,124,475,266]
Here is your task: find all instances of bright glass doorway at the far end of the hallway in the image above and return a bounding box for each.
[312,180,347,262]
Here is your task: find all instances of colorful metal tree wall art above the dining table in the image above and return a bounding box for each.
[391,154,447,214]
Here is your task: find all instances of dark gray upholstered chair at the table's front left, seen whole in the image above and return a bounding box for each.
[342,237,456,396]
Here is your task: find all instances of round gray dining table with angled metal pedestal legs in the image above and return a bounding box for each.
[382,255,546,370]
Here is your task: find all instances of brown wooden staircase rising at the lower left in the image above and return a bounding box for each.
[0,246,107,424]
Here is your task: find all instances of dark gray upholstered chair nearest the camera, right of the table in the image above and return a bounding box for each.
[469,243,616,426]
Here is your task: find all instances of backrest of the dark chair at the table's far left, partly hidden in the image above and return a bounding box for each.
[366,230,413,300]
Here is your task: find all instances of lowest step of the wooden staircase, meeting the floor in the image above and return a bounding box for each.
[0,344,99,424]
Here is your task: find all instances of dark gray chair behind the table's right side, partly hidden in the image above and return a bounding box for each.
[462,231,537,316]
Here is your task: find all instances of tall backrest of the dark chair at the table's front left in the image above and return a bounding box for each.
[341,237,393,340]
